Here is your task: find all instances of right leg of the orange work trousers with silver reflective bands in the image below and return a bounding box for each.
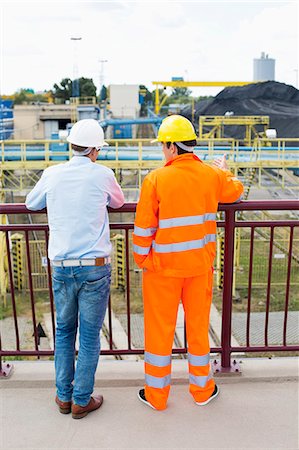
[182,270,215,402]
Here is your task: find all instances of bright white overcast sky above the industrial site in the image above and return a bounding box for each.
[0,0,298,95]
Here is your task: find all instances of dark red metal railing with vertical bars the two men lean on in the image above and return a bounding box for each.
[0,200,299,370]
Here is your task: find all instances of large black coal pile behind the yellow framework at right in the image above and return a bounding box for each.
[181,81,299,139]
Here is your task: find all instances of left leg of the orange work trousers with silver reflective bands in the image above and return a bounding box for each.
[143,271,183,410]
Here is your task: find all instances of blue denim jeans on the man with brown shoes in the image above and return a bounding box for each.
[52,264,111,406]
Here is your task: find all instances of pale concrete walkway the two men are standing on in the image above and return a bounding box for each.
[0,358,298,450]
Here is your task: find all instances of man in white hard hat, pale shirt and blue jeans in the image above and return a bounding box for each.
[26,119,124,419]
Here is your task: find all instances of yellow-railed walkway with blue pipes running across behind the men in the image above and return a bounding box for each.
[0,138,299,168]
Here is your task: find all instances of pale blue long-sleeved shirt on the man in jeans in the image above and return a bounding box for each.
[26,156,124,260]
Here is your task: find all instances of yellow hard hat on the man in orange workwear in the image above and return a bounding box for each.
[157,114,196,142]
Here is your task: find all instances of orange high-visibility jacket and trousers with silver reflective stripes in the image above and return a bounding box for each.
[133,153,243,410]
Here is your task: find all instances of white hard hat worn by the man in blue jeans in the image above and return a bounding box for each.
[67,119,109,150]
